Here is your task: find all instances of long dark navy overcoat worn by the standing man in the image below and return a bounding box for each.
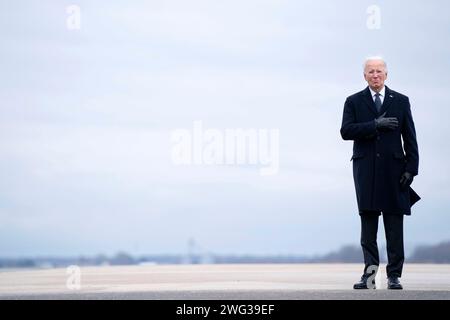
[341,87,420,215]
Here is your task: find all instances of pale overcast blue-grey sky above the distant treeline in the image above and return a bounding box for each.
[0,0,450,256]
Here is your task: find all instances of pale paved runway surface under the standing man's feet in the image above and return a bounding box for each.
[0,264,450,300]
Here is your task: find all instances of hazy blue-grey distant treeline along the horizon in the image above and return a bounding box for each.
[0,241,450,268]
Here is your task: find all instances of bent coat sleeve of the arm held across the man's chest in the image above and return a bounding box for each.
[341,98,378,140]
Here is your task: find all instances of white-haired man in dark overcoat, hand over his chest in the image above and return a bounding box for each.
[341,57,420,289]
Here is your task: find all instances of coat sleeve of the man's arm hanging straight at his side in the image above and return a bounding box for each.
[402,99,419,176]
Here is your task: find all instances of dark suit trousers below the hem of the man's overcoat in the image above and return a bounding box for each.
[360,211,405,277]
